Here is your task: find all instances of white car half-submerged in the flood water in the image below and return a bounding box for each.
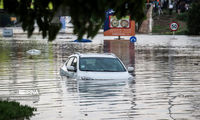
[60,53,134,80]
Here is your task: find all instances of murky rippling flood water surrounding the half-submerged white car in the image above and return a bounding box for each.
[0,35,200,120]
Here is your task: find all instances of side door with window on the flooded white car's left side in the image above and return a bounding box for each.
[65,57,77,78]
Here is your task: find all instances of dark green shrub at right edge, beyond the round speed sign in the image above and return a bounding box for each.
[187,0,200,35]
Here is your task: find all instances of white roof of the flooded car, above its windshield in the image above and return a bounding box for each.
[76,53,117,58]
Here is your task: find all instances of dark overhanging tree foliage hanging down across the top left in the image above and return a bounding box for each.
[3,0,146,41]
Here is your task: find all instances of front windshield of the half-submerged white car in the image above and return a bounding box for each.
[79,57,126,72]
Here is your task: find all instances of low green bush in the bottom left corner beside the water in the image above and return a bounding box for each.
[0,101,36,120]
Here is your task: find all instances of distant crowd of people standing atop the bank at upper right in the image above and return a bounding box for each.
[148,0,194,15]
